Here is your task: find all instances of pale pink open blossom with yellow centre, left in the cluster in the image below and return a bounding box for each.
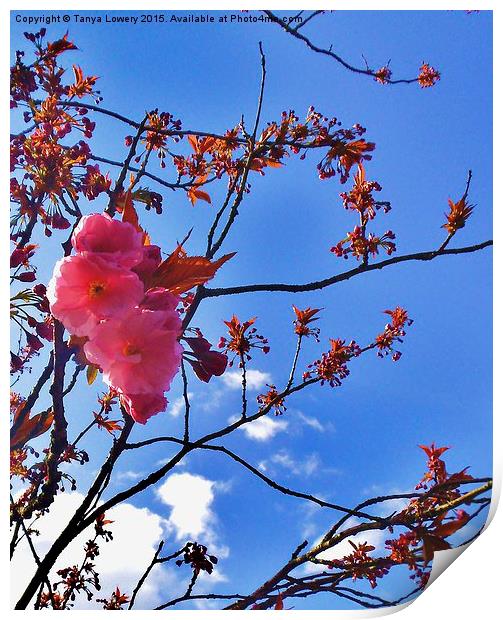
[47,256,144,336]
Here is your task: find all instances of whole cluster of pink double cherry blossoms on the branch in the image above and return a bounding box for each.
[47,214,182,424]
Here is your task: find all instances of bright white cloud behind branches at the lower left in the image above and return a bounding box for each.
[11,471,229,610]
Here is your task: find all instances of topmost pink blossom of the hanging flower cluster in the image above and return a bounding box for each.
[72,213,143,268]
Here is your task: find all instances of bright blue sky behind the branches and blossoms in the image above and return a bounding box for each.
[11,11,492,609]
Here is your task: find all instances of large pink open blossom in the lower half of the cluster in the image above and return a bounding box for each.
[84,308,182,395]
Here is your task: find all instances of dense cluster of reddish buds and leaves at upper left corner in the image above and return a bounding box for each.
[11,28,138,246]
